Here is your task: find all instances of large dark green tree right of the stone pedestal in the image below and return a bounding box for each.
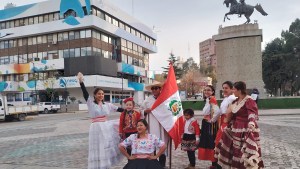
[262,19,300,96]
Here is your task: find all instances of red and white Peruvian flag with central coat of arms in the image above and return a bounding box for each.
[151,64,183,149]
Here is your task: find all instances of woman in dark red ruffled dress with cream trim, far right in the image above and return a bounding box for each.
[215,81,264,169]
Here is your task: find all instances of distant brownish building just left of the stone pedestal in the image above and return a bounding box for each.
[199,38,217,67]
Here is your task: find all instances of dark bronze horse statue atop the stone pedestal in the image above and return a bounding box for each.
[224,0,268,24]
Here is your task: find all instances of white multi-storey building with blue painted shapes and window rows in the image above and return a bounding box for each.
[0,0,157,104]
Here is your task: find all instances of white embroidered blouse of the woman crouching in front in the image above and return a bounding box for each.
[121,134,165,154]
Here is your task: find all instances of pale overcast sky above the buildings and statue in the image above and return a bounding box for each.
[0,0,300,71]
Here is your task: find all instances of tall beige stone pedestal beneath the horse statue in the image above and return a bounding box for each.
[213,24,265,98]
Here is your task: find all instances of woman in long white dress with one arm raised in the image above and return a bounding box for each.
[77,72,123,169]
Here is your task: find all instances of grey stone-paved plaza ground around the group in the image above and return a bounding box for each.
[0,109,300,169]
